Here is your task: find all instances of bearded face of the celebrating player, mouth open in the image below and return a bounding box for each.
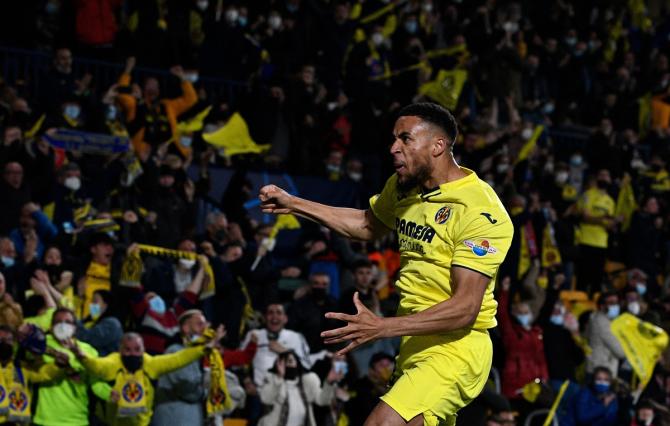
[391,116,433,189]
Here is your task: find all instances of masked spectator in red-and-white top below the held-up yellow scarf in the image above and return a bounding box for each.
[131,256,207,355]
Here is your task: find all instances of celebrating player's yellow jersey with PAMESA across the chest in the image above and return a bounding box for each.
[370,167,514,330]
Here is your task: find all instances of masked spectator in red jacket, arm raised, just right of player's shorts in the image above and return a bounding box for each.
[498,278,549,400]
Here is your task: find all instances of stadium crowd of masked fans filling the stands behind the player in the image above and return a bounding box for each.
[0,0,670,426]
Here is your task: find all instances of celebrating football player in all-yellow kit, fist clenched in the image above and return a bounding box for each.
[259,103,513,426]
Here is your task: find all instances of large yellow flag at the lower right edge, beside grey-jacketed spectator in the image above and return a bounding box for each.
[611,313,668,389]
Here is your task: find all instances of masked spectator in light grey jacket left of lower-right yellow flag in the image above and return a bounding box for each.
[586,292,626,373]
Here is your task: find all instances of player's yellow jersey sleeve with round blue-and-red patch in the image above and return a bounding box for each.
[451,210,514,278]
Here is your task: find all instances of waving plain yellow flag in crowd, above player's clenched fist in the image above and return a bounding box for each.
[202,112,270,157]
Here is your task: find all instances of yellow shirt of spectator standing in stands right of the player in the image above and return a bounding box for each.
[577,188,615,248]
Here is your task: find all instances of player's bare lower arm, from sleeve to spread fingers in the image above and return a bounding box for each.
[321,267,491,355]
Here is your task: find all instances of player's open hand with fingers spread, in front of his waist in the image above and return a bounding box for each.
[321,292,385,356]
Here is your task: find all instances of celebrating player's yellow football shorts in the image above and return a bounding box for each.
[381,330,493,426]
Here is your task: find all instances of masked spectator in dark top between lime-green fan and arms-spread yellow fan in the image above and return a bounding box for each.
[77,290,123,356]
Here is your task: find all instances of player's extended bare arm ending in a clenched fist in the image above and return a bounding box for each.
[258,185,389,241]
